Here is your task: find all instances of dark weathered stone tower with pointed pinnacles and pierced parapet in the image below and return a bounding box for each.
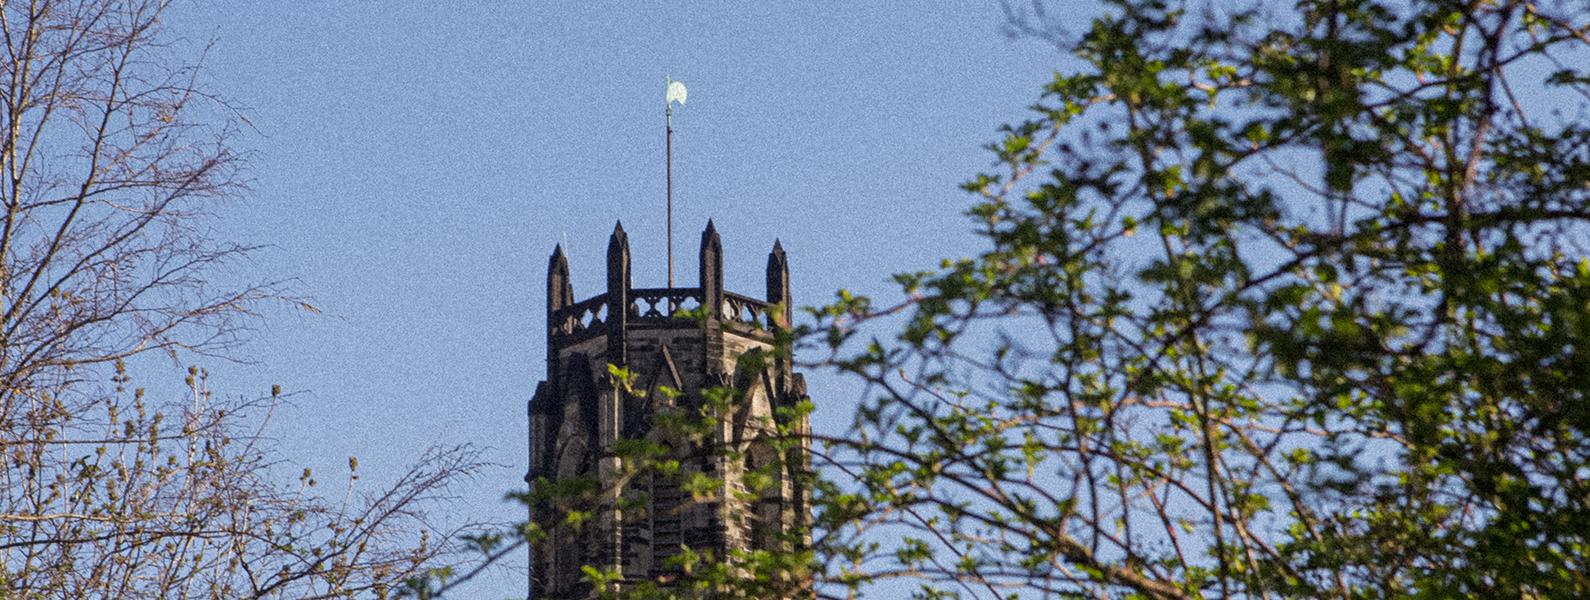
[526,221,809,600]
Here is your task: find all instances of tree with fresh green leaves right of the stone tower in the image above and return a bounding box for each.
[817,0,1590,598]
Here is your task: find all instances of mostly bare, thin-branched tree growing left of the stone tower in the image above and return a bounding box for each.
[0,0,475,598]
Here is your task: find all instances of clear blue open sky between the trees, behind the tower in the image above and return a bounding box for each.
[158,0,1081,597]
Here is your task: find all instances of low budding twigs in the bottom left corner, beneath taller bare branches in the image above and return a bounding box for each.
[0,369,477,598]
